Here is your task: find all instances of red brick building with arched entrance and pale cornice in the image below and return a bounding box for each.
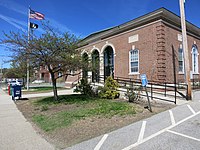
[77,8,200,83]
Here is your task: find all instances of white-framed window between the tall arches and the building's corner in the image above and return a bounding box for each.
[129,50,139,74]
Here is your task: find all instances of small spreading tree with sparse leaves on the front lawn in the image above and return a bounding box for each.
[1,25,81,100]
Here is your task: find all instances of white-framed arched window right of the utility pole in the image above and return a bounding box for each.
[192,44,199,74]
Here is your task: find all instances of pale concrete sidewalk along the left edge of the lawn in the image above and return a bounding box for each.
[0,89,55,150]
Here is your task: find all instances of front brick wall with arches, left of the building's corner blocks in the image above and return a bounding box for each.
[79,23,160,80]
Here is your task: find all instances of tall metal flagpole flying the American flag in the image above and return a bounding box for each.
[26,5,30,91]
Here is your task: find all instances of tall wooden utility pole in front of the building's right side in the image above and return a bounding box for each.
[179,0,192,100]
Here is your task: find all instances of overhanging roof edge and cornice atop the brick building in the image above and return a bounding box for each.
[80,7,200,47]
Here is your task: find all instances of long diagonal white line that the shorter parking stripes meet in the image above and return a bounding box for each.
[122,111,200,150]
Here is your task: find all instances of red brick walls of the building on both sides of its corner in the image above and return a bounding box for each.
[78,21,200,82]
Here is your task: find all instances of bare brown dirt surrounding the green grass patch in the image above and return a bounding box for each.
[16,99,175,149]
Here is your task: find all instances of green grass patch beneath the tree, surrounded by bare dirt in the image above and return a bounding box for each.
[33,95,136,132]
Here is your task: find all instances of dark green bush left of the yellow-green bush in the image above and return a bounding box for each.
[74,78,95,96]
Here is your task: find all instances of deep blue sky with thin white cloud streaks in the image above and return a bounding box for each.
[0,0,200,68]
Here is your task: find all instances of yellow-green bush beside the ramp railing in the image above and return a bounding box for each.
[99,76,119,99]
